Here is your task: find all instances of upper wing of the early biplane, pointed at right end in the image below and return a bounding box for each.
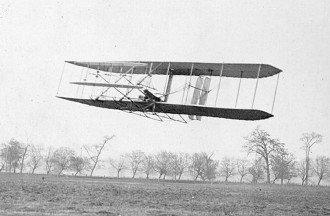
[67,61,282,78]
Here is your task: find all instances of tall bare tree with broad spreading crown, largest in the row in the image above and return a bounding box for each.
[243,127,284,184]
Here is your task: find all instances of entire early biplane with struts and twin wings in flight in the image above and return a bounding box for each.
[57,61,282,123]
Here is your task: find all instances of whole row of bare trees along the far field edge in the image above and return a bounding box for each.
[0,127,330,185]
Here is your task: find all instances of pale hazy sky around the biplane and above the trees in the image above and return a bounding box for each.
[0,0,330,170]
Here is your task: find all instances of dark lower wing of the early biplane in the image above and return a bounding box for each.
[59,97,273,121]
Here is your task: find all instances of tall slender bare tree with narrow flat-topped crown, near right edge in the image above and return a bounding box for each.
[300,132,322,185]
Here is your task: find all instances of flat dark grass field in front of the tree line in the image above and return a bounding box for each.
[0,173,330,216]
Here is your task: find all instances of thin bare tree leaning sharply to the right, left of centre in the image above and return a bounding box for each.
[84,135,115,176]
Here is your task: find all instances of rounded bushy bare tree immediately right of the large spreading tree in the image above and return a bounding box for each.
[271,148,295,184]
